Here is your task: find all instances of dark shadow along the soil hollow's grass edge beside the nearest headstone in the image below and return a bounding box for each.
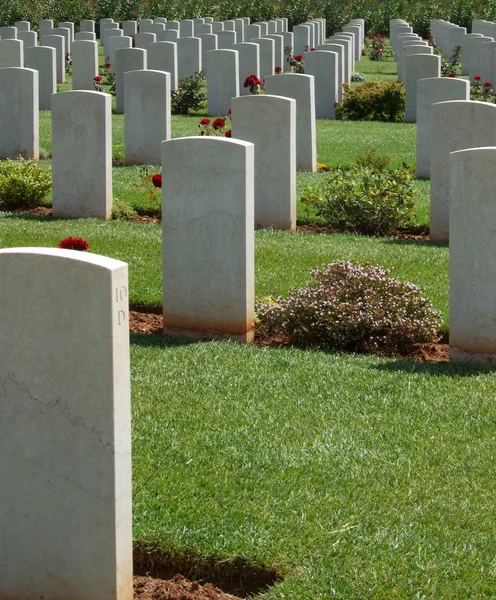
[133,540,283,598]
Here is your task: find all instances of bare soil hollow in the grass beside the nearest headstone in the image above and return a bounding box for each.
[133,542,282,600]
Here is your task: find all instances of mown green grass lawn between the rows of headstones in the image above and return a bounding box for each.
[0,48,496,600]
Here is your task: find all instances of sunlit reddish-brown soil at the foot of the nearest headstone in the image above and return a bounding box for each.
[133,574,240,600]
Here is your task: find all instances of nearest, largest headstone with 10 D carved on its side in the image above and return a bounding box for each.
[0,246,133,600]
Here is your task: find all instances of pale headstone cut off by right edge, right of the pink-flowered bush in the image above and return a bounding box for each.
[449,147,496,366]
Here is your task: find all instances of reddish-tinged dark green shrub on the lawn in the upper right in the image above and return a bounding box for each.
[336,80,405,122]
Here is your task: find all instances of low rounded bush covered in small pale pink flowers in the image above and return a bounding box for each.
[256,261,440,353]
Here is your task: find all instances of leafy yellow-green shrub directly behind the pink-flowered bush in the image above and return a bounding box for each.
[301,167,416,235]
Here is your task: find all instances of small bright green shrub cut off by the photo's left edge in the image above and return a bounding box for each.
[0,159,52,209]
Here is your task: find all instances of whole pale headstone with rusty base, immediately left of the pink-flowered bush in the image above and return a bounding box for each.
[162,136,254,343]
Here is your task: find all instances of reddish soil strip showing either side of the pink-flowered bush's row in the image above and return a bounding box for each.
[129,310,449,362]
